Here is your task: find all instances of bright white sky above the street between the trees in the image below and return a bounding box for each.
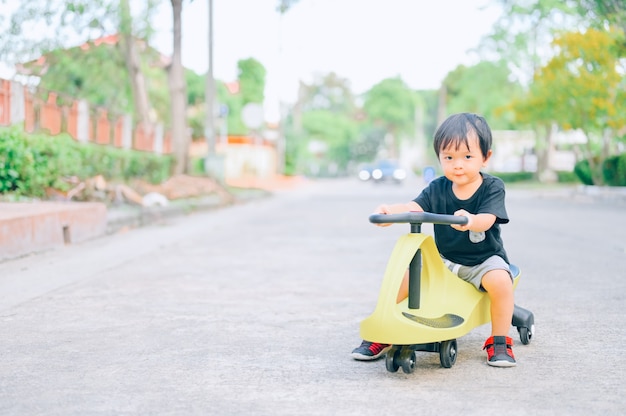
[152,0,500,120]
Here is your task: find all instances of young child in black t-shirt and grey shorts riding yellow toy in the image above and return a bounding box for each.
[352,113,516,367]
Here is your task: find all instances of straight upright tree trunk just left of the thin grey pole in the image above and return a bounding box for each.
[168,0,189,174]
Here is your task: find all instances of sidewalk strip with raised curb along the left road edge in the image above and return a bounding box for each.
[0,176,306,261]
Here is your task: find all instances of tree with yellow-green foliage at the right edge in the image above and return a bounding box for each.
[518,29,626,185]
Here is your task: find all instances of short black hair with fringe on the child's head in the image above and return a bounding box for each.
[433,113,492,157]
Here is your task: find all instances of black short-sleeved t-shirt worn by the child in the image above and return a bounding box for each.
[414,173,509,266]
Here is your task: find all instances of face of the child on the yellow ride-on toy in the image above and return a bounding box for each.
[439,132,491,186]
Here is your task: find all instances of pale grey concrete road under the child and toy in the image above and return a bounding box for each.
[0,179,626,416]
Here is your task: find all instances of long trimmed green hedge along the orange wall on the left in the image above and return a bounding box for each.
[0,127,174,197]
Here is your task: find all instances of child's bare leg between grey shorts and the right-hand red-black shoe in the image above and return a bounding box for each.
[482,270,515,336]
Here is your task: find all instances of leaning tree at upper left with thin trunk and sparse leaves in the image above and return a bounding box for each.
[0,0,163,151]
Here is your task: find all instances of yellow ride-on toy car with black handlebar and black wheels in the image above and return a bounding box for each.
[360,212,535,374]
